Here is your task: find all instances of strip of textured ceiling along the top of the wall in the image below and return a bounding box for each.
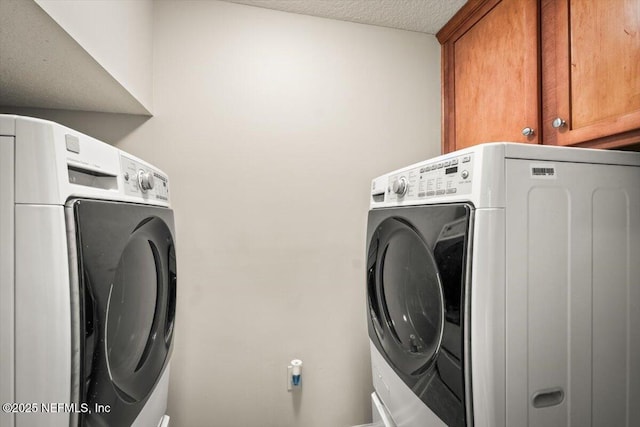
[223,0,467,34]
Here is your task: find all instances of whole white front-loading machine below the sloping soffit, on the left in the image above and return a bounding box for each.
[0,115,176,427]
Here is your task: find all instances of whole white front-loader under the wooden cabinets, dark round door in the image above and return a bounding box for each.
[366,143,640,427]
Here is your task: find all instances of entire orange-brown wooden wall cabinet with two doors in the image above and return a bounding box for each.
[437,0,640,152]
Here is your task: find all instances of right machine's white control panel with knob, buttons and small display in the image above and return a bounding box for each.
[385,153,473,202]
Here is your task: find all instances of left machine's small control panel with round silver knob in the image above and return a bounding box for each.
[120,155,169,201]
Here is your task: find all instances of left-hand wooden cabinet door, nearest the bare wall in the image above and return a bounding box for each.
[438,0,540,152]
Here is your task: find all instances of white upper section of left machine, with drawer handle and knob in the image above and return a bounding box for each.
[0,114,170,207]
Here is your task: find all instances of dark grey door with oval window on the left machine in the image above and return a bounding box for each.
[73,200,176,426]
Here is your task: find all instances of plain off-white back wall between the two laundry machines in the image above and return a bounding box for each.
[118,1,440,427]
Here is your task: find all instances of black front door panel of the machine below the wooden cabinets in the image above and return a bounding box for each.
[367,204,473,427]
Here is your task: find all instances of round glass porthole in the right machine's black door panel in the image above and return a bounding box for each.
[369,218,444,374]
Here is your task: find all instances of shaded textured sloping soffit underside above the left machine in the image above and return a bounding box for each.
[0,0,150,116]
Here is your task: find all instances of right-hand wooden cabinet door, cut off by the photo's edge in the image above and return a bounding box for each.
[541,0,640,148]
